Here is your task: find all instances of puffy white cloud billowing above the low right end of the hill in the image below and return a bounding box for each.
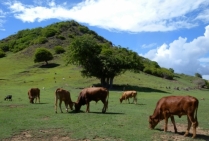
[143,25,209,75]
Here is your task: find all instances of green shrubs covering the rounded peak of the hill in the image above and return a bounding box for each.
[0,21,110,52]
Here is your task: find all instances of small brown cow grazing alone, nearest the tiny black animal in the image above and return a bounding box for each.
[28,88,40,104]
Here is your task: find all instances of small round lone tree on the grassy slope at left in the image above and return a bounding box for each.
[34,48,53,65]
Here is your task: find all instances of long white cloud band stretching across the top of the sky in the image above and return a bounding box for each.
[4,0,209,32]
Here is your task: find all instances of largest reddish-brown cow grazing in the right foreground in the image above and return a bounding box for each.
[149,96,199,138]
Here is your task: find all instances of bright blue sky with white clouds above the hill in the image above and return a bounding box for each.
[0,0,209,79]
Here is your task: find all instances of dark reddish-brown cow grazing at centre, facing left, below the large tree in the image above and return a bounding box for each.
[75,87,109,113]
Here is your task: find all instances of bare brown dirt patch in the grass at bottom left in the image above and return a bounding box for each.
[2,129,123,141]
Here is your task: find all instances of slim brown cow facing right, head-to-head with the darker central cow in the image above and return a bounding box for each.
[55,88,73,113]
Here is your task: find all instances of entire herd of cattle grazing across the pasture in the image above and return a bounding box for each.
[4,87,199,138]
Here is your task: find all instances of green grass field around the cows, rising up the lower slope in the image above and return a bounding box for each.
[0,53,209,141]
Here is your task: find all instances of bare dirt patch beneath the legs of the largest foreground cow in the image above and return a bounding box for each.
[153,122,209,141]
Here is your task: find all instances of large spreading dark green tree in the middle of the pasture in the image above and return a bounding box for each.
[66,35,144,87]
